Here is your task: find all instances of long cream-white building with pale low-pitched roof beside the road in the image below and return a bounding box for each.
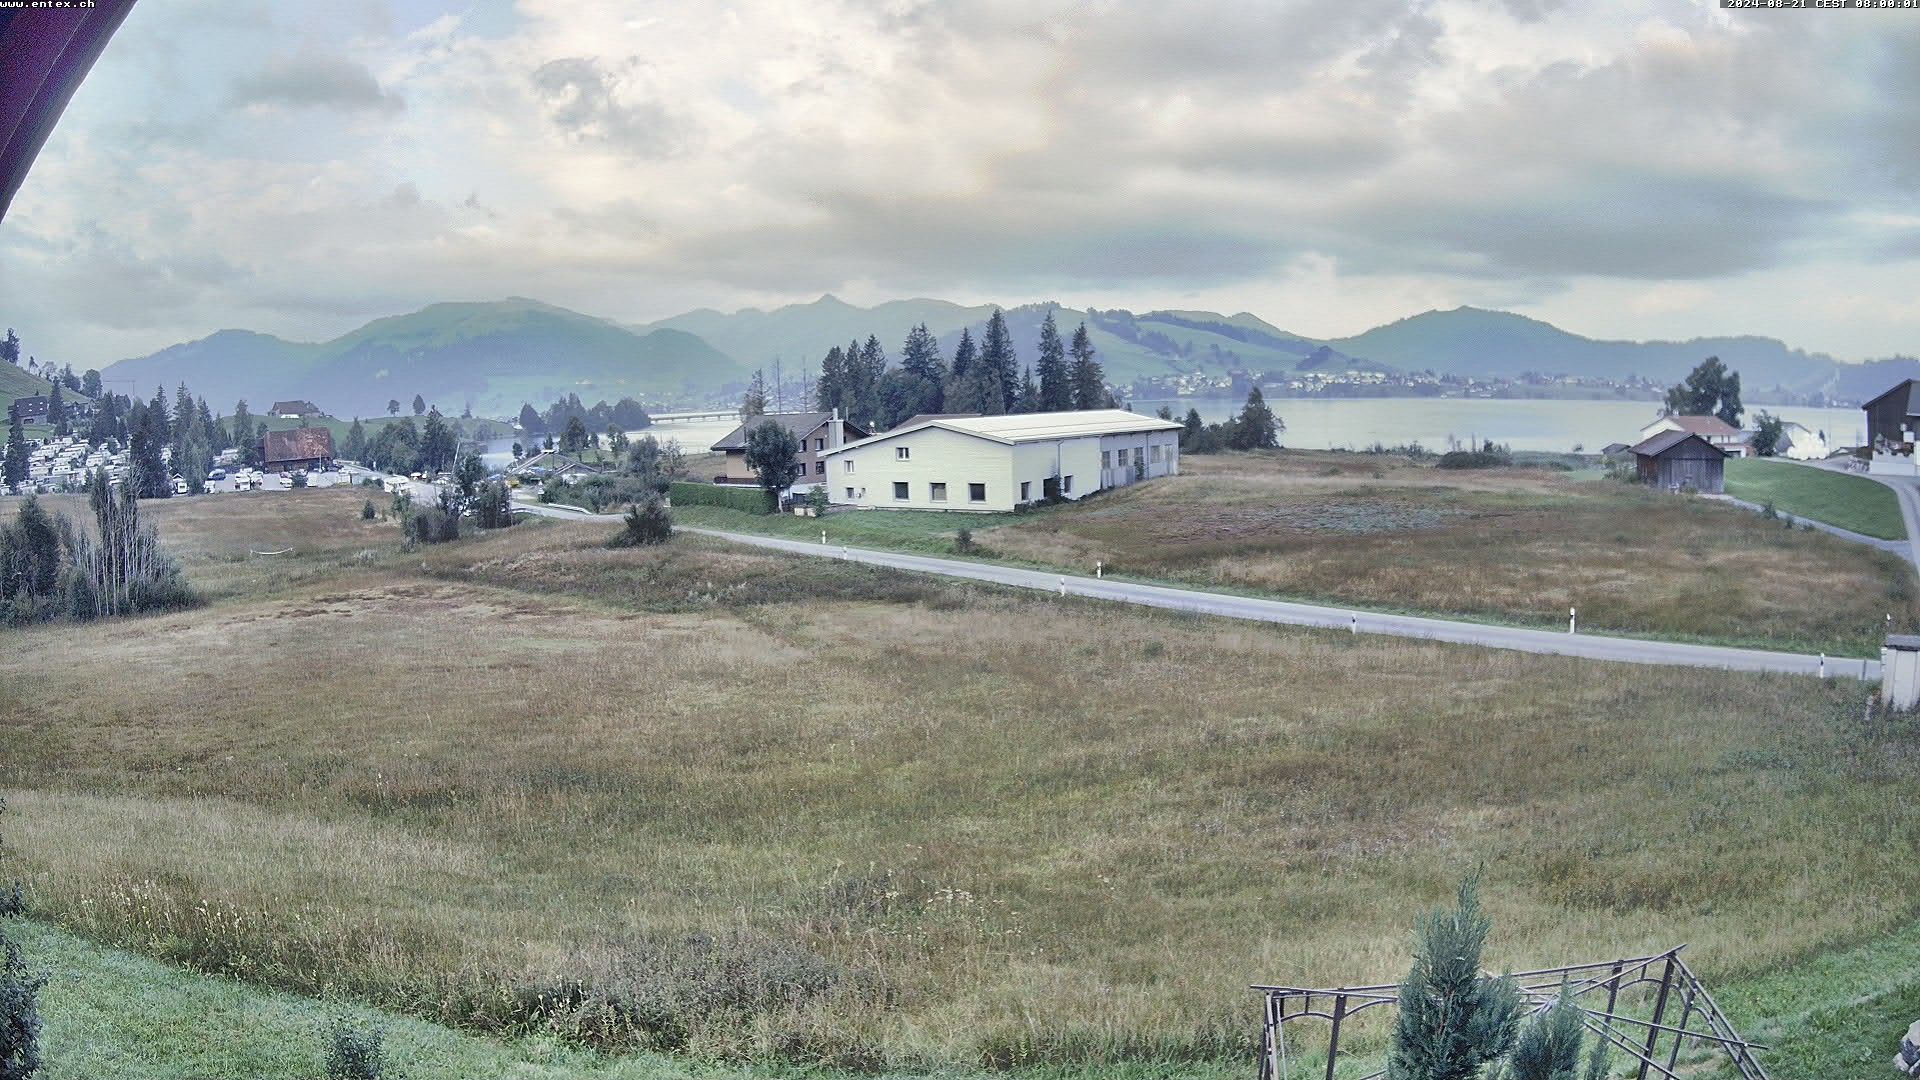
[826,409,1181,511]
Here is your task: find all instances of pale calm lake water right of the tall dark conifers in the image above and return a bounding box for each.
[1133,398,1866,454]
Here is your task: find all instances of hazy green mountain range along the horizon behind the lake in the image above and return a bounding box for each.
[108,296,1920,417]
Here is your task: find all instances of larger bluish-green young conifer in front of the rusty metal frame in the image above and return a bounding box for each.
[1386,878,1521,1080]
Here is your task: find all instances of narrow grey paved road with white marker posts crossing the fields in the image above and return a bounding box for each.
[516,503,1880,680]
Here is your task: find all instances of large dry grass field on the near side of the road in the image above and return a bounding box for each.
[0,490,1920,1068]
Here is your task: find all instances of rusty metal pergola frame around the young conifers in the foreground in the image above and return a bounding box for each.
[1254,945,1768,1080]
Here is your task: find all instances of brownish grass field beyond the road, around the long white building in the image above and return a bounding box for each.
[676,452,1920,655]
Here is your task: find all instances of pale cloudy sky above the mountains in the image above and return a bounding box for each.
[0,0,1920,369]
